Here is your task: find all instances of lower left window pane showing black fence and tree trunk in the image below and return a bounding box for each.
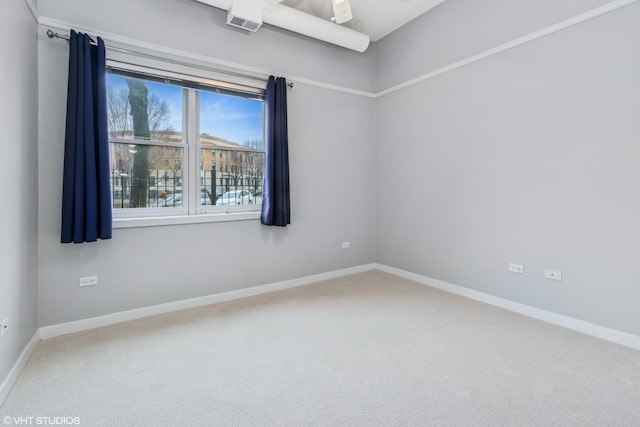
[109,141,183,209]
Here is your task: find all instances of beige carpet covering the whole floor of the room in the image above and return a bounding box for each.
[0,271,640,426]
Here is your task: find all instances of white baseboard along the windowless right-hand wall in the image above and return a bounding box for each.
[376,264,640,350]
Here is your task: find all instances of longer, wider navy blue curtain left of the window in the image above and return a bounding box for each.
[61,30,112,243]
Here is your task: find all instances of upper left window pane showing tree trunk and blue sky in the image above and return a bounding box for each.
[107,74,183,142]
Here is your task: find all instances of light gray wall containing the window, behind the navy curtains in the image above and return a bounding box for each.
[38,0,375,326]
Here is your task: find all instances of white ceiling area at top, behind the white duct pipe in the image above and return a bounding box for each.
[280,0,444,41]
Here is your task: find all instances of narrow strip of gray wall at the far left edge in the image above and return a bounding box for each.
[0,0,38,382]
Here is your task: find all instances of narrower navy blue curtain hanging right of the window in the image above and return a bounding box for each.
[261,76,291,227]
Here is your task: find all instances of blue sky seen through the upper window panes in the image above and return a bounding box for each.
[107,74,263,144]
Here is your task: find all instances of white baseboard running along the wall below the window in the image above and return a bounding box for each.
[40,264,376,339]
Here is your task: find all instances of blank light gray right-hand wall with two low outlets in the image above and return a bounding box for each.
[376,0,640,335]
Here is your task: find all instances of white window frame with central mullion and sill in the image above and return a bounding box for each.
[107,52,266,228]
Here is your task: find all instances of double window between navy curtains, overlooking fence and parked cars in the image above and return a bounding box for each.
[107,67,264,224]
